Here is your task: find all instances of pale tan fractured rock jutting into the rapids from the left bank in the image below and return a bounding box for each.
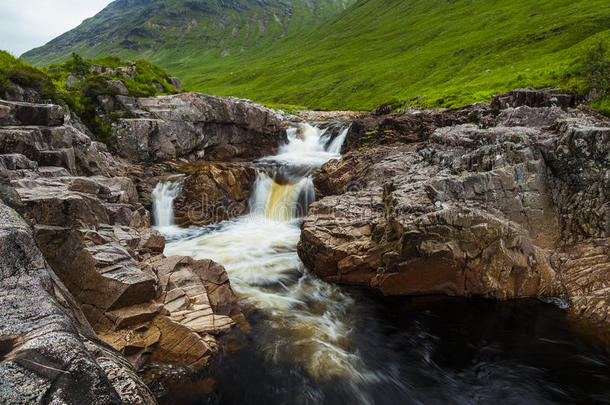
[99,256,247,368]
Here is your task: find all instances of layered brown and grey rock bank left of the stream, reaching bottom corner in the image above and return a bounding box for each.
[0,97,246,404]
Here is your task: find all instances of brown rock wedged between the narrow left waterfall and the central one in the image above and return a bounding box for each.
[174,162,256,226]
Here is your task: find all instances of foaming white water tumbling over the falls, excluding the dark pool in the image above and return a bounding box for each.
[154,124,372,388]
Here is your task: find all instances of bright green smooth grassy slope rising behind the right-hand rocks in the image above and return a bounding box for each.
[180,0,610,109]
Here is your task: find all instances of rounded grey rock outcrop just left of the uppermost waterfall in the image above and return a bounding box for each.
[113,93,285,162]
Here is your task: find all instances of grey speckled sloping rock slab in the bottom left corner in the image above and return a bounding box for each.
[0,203,156,405]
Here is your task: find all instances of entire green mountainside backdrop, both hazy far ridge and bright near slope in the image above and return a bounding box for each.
[24,0,610,111]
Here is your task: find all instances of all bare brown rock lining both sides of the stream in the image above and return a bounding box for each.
[0,90,610,404]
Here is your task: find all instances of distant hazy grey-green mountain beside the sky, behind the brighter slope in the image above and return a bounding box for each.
[23,0,350,65]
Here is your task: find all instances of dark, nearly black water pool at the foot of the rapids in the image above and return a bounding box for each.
[196,292,610,405]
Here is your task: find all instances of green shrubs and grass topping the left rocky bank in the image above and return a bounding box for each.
[0,51,178,145]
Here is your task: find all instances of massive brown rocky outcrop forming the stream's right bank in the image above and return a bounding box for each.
[299,93,610,321]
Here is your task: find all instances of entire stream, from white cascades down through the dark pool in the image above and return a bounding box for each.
[154,124,610,404]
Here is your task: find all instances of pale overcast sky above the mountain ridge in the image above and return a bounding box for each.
[0,0,113,56]
